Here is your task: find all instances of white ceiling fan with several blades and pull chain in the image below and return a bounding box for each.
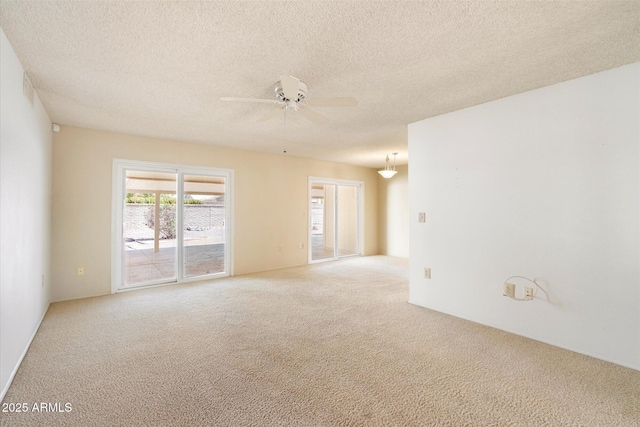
[220,76,358,125]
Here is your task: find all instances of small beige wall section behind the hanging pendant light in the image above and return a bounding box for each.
[378,165,410,258]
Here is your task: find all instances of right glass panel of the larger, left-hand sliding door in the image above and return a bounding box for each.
[182,175,226,278]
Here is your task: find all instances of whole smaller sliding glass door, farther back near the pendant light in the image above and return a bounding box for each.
[309,177,364,262]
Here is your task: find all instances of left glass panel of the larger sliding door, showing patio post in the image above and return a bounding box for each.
[122,170,177,287]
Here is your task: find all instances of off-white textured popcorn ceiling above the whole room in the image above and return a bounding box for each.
[0,0,640,167]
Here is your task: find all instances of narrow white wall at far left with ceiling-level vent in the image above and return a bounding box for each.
[0,31,52,400]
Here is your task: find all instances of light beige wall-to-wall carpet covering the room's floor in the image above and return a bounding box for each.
[0,256,640,427]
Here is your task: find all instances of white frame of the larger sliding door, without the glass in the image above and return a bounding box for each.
[111,159,234,294]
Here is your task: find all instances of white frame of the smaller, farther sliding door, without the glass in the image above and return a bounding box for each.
[307,176,364,264]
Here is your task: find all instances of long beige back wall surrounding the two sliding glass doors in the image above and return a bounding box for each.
[52,126,378,301]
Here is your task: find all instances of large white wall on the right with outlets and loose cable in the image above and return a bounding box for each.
[409,63,640,369]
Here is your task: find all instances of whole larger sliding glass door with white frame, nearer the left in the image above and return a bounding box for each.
[112,160,232,292]
